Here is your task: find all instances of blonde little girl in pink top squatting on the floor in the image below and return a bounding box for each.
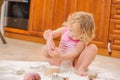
[41,12,97,76]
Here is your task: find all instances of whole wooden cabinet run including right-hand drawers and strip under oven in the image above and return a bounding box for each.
[6,0,120,57]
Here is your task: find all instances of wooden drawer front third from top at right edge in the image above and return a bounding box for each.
[110,19,120,35]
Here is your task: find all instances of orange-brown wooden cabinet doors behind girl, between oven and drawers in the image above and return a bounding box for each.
[30,0,110,48]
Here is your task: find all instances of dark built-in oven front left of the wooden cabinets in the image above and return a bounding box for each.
[6,0,30,30]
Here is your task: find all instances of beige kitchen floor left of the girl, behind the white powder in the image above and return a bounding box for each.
[0,38,44,61]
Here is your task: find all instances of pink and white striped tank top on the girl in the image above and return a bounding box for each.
[59,27,79,52]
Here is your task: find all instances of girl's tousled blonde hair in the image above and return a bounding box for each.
[67,12,95,42]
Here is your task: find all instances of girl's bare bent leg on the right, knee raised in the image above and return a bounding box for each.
[74,44,97,76]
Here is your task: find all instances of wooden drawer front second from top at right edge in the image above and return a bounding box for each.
[111,4,120,19]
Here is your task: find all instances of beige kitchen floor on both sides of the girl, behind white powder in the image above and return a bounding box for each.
[0,38,120,76]
